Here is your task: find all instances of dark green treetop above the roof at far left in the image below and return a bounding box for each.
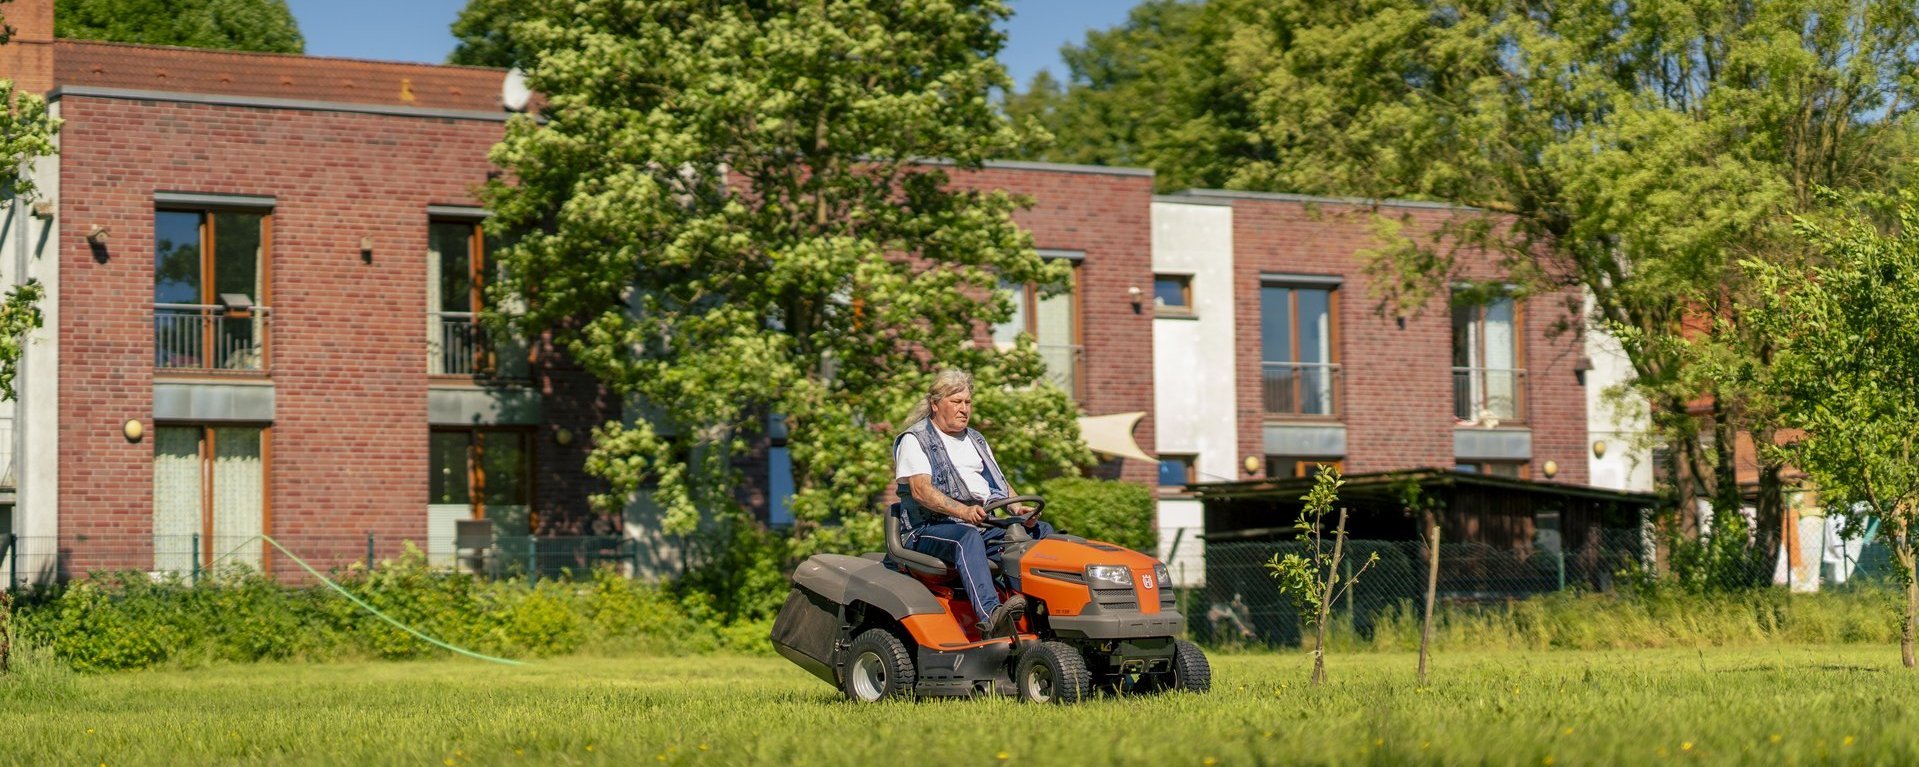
[54,0,307,54]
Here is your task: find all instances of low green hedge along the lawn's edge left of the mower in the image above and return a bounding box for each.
[13,548,768,671]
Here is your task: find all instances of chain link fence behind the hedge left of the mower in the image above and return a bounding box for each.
[0,533,641,589]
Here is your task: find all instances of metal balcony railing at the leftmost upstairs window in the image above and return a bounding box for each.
[154,303,271,372]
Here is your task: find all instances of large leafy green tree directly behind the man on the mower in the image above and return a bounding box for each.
[486,0,1090,554]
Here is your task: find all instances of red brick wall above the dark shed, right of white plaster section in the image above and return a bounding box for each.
[1232,199,1587,483]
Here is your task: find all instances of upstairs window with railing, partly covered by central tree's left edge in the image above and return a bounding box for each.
[426,221,526,378]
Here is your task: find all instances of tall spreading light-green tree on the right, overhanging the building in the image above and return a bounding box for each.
[1219,0,1919,579]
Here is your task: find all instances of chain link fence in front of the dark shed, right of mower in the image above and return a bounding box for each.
[1180,529,1647,646]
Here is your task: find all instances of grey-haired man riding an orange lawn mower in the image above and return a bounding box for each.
[773,372,1211,704]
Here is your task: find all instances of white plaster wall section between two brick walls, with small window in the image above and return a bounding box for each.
[1153,199,1240,587]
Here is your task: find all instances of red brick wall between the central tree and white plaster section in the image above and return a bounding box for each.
[956,167,1159,485]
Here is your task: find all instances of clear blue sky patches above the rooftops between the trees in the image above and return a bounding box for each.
[286,0,1136,86]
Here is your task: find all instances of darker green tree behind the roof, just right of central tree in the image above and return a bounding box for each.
[1006,0,1267,190]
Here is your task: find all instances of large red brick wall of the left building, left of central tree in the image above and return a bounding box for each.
[58,96,599,573]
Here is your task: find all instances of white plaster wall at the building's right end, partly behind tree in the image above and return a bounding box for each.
[1585,295,1652,493]
